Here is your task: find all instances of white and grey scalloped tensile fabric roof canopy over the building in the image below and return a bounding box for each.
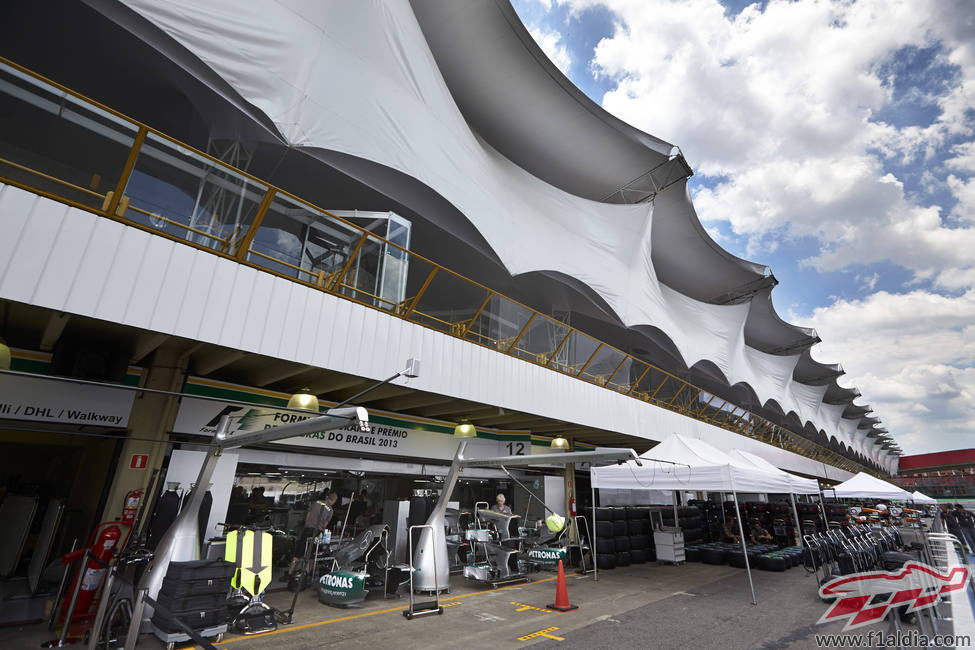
[89,0,896,472]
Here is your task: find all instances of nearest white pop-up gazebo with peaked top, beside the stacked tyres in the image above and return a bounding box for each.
[589,433,796,604]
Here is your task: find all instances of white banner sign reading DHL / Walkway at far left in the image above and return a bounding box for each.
[0,368,135,428]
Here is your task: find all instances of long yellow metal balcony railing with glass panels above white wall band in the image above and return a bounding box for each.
[0,58,874,472]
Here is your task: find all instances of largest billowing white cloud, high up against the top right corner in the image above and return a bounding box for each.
[563,0,975,286]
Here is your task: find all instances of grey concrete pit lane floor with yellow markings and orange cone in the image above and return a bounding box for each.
[0,563,975,650]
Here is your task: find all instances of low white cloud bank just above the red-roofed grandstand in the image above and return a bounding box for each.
[800,290,975,453]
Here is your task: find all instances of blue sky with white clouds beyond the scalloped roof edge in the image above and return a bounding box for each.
[513,0,975,453]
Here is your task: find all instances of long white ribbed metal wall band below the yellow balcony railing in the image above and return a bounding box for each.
[0,186,850,479]
